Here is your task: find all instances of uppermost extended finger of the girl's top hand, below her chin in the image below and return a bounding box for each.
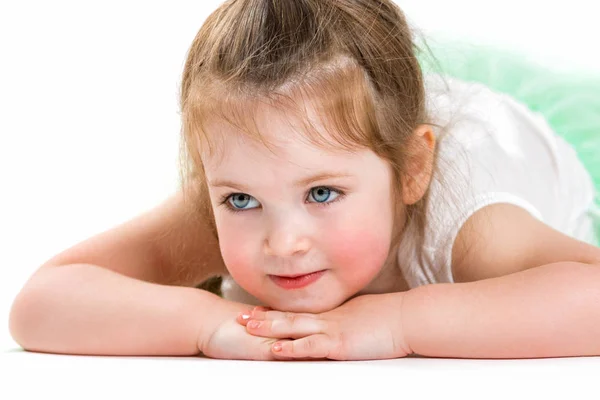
[246,314,328,339]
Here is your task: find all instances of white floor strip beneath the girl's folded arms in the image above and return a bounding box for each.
[0,352,600,400]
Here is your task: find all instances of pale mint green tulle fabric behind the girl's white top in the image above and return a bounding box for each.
[418,41,600,246]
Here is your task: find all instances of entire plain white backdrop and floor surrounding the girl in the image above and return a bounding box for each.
[0,0,600,399]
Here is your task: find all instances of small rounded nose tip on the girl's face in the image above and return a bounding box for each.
[264,214,310,257]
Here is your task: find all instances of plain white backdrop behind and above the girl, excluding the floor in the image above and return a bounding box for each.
[0,0,600,396]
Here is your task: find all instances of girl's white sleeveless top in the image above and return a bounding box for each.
[398,75,594,288]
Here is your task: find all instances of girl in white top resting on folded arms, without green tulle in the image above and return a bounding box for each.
[10,0,600,360]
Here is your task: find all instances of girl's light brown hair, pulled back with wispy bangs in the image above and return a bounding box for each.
[180,0,448,288]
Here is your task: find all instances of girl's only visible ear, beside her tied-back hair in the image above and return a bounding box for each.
[402,125,436,205]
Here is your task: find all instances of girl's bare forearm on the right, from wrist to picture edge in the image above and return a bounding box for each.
[403,262,600,358]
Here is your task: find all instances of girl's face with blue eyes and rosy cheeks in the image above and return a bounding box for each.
[203,102,394,313]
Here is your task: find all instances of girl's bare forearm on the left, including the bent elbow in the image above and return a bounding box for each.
[10,264,230,355]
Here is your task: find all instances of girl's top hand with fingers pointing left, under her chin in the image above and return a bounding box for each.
[237,292,412,360]
